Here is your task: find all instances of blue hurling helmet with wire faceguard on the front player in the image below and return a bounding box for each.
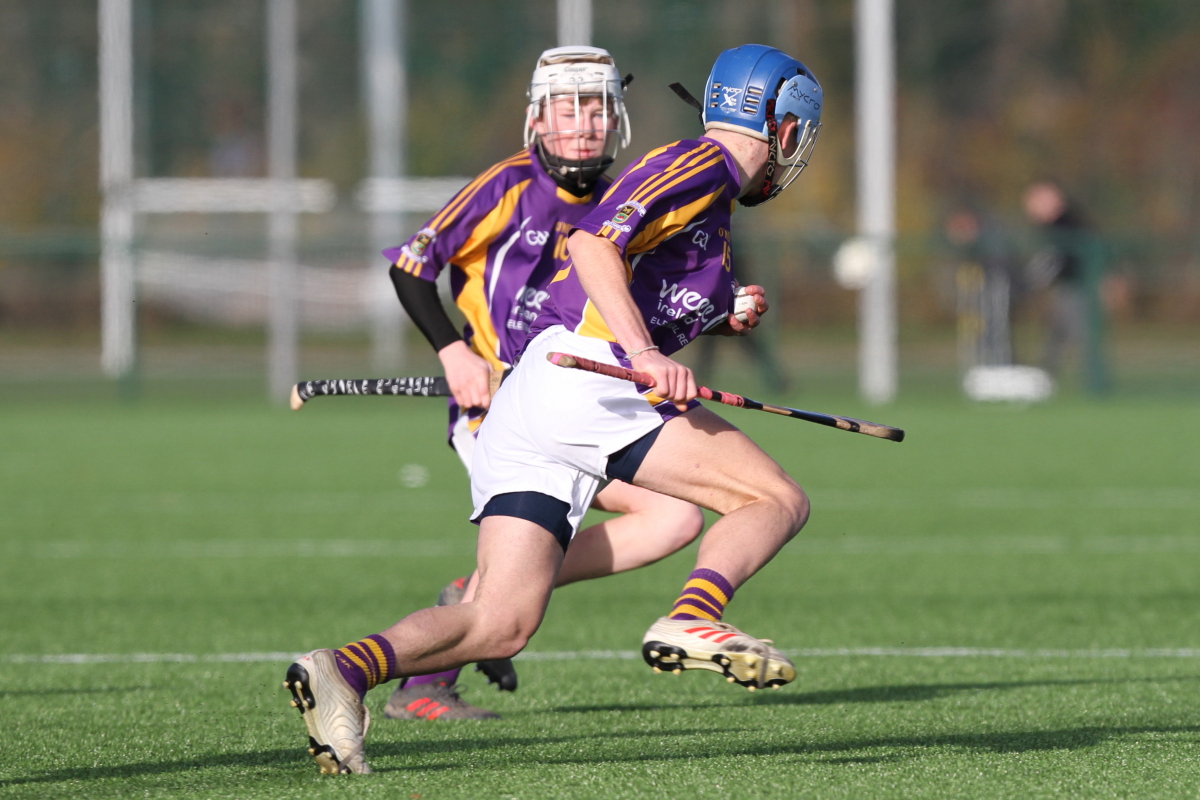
[701,44,822,205]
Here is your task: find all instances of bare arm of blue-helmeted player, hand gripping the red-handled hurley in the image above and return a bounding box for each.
[566,230,696,405]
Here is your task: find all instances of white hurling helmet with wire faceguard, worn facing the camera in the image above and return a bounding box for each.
[524,44,634,197]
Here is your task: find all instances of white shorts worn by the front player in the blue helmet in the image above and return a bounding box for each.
[470,325,678,534]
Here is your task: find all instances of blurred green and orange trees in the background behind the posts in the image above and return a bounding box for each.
[0,0,1200,331]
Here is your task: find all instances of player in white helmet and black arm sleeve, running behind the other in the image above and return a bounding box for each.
[360,47,703,720]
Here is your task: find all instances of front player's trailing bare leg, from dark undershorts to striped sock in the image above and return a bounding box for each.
[383,517,563,676]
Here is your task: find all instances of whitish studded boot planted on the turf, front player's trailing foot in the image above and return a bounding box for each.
[283,650,371,775]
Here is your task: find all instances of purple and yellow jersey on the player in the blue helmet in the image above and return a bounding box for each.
[530,139,740,359]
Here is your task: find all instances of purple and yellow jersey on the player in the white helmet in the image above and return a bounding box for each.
[383,149,608,369]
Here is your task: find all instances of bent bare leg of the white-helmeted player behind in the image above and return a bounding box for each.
[462,481,704,603]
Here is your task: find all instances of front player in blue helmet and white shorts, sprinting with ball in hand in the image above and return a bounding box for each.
[286,44,821,771]
